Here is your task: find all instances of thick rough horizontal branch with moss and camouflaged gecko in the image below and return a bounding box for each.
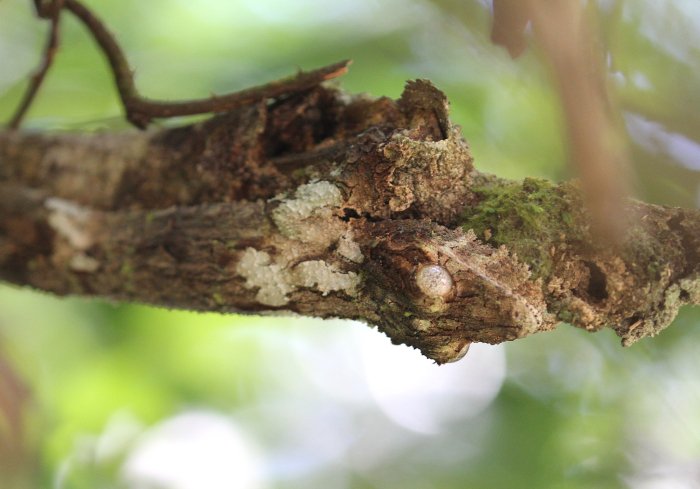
[0,80,700,363]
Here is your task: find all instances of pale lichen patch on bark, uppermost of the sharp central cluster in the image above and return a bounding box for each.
[272,181,343,240]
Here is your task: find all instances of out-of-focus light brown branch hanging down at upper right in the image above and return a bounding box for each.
[491,0,630,244]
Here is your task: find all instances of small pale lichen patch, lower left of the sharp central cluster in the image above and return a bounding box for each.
[236,248,294,307]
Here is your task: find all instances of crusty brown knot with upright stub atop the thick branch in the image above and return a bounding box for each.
[342,80,474,224]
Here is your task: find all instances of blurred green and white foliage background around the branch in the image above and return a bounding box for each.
[0,0,700,489]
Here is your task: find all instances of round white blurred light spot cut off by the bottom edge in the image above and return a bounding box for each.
[122,411,264,489]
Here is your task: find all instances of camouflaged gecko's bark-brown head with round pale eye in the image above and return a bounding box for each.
[364,220,545,363]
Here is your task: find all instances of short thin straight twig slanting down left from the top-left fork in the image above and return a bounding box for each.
[8,0,63,129]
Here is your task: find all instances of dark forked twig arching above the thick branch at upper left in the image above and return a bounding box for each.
[10,0,350,129]
